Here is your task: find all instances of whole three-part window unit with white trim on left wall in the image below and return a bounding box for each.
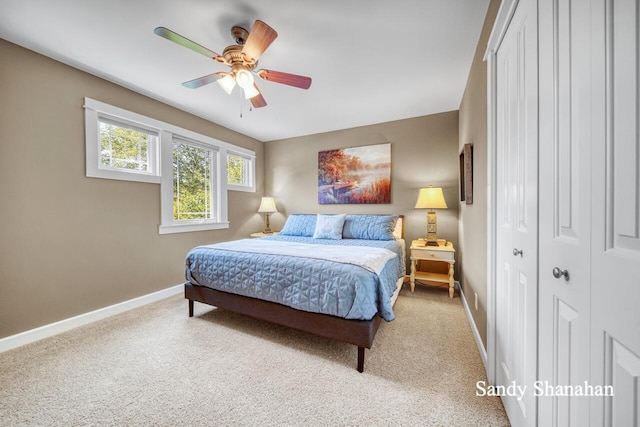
[84,98,255,234]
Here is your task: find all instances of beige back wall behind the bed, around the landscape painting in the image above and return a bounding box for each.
[265,111,459,272]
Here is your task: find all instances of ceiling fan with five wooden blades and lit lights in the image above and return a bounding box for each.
[153,20,311,108]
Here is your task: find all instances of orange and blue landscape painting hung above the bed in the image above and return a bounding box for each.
[318,143,391,205]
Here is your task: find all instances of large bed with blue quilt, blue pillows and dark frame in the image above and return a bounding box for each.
[185,214,405,372]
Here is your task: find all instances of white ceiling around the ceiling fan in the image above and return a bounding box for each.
[0,0,489,141]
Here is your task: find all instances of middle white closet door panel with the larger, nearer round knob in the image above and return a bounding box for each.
[538,0,597,427]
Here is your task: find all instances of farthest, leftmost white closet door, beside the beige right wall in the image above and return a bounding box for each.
[495,0,538,426]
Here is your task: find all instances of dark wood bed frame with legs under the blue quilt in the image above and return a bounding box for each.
[184,215,404,372]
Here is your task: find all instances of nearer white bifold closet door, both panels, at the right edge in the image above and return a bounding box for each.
[538,0,640,427]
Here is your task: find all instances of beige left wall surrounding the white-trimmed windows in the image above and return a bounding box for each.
[0,40,264,337]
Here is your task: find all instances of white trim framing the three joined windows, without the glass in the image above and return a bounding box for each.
[84,98,255,234]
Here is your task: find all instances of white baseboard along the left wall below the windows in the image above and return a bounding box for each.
[0,284,184,353]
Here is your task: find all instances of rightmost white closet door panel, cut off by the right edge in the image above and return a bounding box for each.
[591,0,640,426]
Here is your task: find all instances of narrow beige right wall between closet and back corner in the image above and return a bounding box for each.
[459,0,500,348]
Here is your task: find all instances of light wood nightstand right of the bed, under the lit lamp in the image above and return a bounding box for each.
[410,240,456,298]
